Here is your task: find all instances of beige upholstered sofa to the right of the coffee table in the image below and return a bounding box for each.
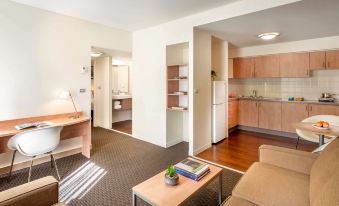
[223,139,339,206]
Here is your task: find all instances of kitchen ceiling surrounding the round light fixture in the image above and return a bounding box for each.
[199,0,339,47]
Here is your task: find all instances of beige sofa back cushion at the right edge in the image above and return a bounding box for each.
[310,139,339,206]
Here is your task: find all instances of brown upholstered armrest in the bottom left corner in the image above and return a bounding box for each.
[0,176,59,206]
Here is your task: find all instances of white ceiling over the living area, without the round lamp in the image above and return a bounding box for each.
[13,0,238,31]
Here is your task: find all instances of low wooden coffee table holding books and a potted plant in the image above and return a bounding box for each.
[132,161,222,206]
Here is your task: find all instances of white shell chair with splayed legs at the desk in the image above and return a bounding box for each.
[7,127,63,182]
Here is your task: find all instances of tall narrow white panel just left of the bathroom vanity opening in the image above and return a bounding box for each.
[93,56,112,129]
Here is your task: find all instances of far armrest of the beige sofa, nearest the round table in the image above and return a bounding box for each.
[259,145,318,175]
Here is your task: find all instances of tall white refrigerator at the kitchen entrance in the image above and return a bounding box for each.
[212,81,226,143]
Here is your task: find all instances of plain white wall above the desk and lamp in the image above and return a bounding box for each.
[0,0,132,120]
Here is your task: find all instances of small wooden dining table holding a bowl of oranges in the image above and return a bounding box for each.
[293,122,339,146]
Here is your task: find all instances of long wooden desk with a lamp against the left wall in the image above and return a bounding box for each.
[0,112,91,158]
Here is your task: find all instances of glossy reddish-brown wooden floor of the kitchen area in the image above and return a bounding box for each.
[197,130,317,172]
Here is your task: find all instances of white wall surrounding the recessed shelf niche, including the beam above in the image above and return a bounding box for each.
[132,0,298,155]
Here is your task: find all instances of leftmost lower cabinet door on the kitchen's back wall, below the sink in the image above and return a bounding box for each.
[239,100,258,127]
